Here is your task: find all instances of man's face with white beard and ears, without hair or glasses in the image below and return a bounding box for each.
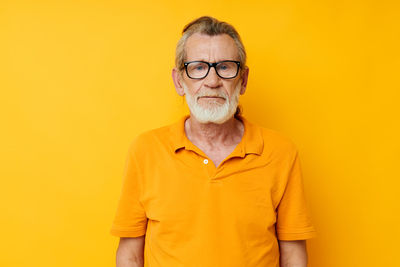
[174,33,247,123]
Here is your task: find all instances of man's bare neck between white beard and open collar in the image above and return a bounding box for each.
[185,115,244,148]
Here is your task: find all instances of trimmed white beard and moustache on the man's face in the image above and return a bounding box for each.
[182,82,241,124]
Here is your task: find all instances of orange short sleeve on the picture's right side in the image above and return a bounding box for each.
[276,149,316,240]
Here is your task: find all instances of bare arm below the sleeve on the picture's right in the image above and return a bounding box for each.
[279,240,307,267]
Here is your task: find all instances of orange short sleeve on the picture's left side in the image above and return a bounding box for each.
[110,144,147,237]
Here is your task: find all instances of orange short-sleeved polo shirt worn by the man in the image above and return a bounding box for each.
[111,116,316,267]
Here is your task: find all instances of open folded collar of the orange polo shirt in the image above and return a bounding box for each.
[170,115,264,157]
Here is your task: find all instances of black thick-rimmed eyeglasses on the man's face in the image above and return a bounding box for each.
[183,60,240,79]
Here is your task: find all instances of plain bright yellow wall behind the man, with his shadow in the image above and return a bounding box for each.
[0,0,400,267]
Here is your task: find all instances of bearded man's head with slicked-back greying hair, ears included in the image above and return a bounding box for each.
[172,17,249,123]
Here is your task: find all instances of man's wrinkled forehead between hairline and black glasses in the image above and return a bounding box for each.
[185,33,239,62]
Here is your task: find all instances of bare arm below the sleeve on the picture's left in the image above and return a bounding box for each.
[117,238,145,267]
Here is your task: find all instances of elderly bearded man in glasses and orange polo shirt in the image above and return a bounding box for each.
[111,17,316,267]
